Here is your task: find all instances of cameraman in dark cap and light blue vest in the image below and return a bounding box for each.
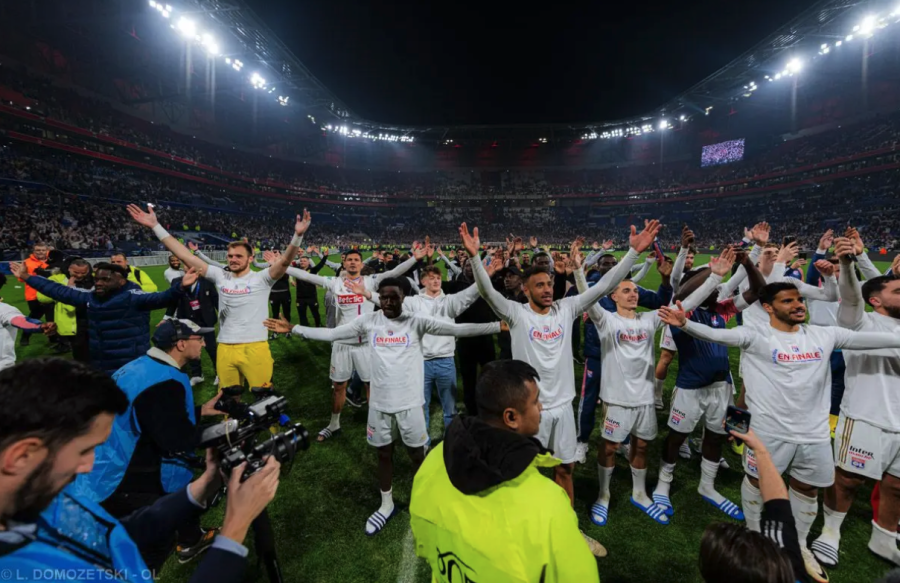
[75,320,225,570]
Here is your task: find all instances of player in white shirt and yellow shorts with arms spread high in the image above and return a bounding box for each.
[128,204,312,387]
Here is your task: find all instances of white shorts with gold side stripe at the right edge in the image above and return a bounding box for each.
[834,413,900,480]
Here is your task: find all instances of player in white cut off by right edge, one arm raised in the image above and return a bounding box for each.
[811,238,900,566]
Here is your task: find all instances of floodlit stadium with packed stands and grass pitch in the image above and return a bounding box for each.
[0,0,900,583]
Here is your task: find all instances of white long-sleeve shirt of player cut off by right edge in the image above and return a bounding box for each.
[838,258,900,432]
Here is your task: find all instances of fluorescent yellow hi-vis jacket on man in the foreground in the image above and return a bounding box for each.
[409,442,599,583]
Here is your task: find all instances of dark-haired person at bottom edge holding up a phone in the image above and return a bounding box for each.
[700,429,809,583]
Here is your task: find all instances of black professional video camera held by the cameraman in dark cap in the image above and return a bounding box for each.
[200,386,309,482]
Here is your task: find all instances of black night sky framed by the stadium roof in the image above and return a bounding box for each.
[247,0,812,125]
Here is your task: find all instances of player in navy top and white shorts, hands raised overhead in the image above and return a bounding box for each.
[653,248,765,520]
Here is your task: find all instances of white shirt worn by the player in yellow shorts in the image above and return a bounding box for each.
[206,265,275,344]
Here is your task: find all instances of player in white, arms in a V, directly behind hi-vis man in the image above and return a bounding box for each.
[459,220,660,542]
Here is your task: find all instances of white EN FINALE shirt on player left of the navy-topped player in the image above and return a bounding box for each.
[588,307,665,407]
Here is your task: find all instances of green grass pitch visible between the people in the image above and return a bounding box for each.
[2,256,889,583]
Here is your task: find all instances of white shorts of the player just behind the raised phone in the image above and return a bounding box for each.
[744,434,834,488]
